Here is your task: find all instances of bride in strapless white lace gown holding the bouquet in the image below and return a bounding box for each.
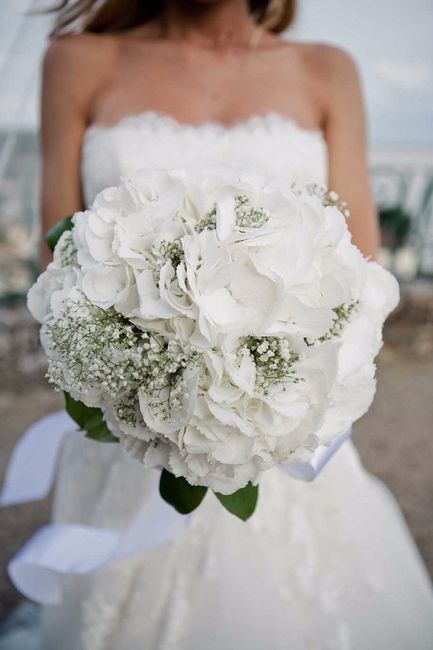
[33,0,433,650]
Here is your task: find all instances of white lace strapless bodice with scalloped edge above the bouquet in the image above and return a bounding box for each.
[82,111,327,205]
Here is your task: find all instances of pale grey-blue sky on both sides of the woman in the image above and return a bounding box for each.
[0,0,433,152]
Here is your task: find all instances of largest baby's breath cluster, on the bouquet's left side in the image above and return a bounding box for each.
[43,296,200,425]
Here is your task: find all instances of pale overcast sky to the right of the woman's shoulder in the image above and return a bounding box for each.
[292,0,433,150]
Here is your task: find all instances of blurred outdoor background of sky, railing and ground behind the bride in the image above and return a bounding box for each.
[0,0,433,650]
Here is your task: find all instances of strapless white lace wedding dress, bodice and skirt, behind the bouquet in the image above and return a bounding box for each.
[44,112,433,650]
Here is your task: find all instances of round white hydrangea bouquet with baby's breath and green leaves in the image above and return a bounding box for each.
[28,172,398,519]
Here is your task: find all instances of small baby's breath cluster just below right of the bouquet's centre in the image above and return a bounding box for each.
[237,336,302,395]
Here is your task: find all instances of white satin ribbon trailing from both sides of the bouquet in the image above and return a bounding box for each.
[0,411,350,605]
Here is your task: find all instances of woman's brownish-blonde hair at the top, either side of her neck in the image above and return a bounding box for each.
[51,0,297,36]
